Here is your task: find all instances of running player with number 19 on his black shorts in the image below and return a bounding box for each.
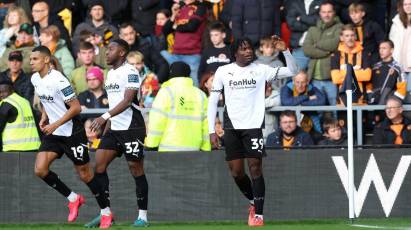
[30,46,107,222]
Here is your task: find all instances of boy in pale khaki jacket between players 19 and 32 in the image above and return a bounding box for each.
[69,42,107,95]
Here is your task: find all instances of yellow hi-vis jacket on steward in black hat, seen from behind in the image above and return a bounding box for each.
[146,77,211,152]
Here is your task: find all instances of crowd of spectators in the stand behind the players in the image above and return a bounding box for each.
[0,0,411,151]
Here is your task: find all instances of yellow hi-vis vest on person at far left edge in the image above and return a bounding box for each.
[0,93,40,152]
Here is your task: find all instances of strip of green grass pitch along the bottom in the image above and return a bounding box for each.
[0,218,411,230]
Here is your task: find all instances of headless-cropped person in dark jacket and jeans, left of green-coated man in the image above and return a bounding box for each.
[286,0,323,70]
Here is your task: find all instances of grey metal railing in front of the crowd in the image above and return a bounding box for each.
[81,105,411,145]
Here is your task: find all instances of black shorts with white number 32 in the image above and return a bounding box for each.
[98,128,146,161]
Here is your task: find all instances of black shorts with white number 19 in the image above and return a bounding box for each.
[39,129,90,165]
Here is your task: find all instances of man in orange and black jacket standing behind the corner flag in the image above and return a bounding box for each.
[331,24,371,104]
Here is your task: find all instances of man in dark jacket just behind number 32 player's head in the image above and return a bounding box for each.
[120,22,168,82]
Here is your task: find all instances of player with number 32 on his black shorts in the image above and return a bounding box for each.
[90,39,148,227]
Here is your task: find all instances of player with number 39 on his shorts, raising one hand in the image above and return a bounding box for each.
[208,37,298,226]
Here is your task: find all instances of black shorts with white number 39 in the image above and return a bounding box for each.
[224,129,266,161]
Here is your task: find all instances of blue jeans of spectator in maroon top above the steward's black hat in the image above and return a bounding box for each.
[160,50,201,87]
